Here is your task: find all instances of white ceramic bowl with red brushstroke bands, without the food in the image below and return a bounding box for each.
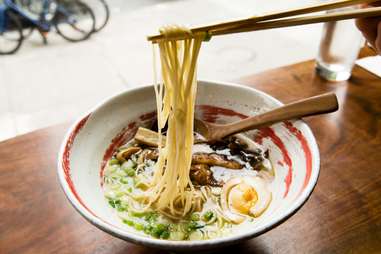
[58,81,319,250]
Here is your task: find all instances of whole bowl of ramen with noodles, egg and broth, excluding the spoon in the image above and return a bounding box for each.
[58,81,319,250]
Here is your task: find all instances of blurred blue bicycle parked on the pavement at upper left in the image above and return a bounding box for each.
[0,0,95,55]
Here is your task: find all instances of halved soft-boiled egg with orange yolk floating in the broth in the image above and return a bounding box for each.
[221,176,272,223]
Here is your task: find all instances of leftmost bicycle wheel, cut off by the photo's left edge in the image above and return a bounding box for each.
[0,11,23,55]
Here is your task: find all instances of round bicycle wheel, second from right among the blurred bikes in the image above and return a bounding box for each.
[54,1,95,42]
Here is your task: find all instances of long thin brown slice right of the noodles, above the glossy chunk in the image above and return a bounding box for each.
[192,153,243,169]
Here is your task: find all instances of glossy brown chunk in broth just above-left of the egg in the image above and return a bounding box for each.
[189,164,223,187]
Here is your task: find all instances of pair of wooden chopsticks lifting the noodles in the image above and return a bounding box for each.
[148,0,381,43]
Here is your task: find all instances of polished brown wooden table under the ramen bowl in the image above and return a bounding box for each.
[0,61,381,254]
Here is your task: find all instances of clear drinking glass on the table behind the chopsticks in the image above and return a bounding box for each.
[316,8,364,81]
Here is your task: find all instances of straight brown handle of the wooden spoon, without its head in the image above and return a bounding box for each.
[218,93,339,137]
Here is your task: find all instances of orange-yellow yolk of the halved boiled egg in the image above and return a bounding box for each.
[229,183,258,214]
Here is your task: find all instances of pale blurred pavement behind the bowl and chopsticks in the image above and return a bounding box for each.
[0,0,322,140]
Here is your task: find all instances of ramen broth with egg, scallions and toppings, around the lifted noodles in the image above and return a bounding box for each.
[103,130,274,240]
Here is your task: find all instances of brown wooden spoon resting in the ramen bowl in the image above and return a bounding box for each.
[194,93,339,142]
